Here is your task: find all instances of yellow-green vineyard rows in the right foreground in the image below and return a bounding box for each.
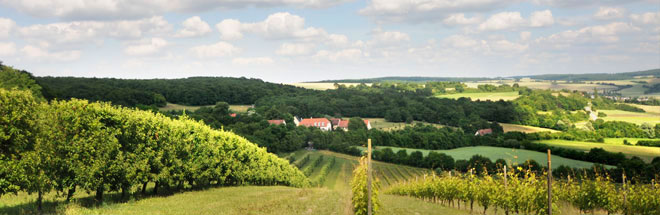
[387,169,660,215]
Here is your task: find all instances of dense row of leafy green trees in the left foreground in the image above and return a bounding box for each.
[0,89,309,212]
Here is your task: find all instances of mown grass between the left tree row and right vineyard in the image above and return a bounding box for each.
[0,150,469,215]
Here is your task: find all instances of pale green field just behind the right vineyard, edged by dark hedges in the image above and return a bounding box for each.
[361,146,593,169]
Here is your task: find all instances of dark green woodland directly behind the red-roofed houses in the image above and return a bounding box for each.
[256,85,515,133]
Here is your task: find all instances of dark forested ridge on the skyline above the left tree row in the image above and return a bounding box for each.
[36,77,311,107]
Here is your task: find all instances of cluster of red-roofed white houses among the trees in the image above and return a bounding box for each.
[268,117,371,131]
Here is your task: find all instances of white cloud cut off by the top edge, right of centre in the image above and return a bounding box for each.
[359,0,517,22]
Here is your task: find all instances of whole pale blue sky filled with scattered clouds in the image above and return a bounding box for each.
[0,0,660,83]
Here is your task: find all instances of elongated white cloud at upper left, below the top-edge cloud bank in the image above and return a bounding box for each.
[19,16,172,43]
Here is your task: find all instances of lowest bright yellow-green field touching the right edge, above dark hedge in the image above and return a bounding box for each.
[537,138,660,162]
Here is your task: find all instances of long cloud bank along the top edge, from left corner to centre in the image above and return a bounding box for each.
[0,0,350,20]
